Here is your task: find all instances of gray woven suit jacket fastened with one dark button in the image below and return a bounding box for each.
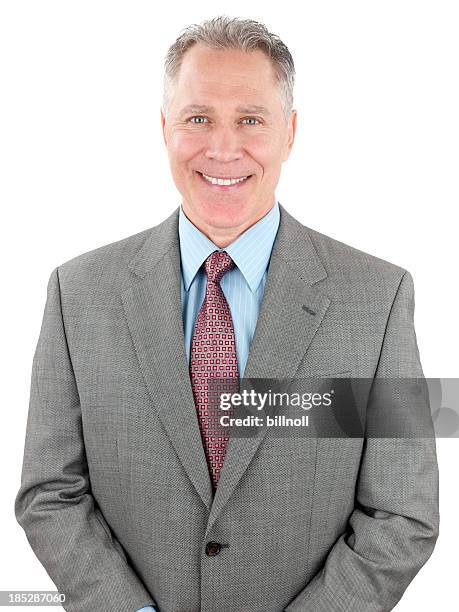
[15,206,439,612]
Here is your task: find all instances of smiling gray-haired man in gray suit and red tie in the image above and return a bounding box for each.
[15,17,439,612]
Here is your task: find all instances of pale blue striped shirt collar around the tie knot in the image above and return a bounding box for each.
[179,202,280,293]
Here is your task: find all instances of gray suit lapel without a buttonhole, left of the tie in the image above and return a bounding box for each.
[121,209,212,508]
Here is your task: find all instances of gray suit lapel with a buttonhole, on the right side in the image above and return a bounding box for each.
[207,206,330,533]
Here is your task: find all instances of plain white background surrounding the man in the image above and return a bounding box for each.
[0,0,459,612]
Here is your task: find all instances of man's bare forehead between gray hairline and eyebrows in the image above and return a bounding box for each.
[174,44,278,106]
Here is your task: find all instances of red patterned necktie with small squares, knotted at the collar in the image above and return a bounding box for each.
[190,251,239,487]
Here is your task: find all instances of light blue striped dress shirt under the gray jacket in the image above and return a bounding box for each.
[137,202,280,612]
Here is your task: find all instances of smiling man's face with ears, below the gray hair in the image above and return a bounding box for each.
[161,44,296,231]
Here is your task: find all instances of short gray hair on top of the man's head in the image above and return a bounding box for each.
[162,15,295,120]
